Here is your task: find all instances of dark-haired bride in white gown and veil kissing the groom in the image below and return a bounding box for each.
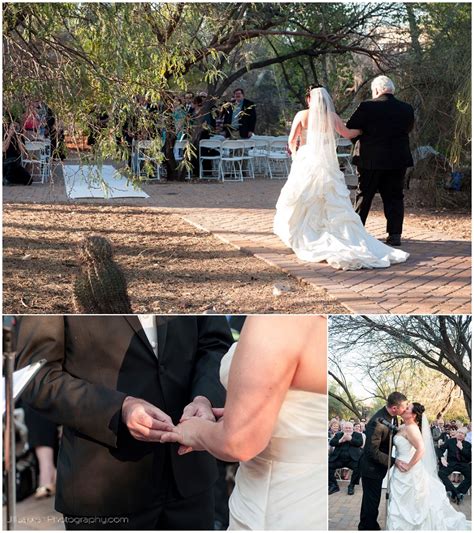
[387,402,471,531]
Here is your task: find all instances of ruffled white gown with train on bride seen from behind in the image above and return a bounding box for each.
[273,131,408,270]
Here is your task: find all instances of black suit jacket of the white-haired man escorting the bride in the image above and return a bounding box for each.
[347,94,414,170]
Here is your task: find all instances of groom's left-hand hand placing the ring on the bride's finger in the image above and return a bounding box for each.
[122,396,175,442]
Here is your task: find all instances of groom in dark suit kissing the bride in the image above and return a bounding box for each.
[358,392,408,531]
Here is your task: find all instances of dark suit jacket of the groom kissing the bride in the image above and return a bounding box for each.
[360,407,398,479]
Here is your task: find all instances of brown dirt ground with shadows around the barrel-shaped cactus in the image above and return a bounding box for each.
[3,204,348,314]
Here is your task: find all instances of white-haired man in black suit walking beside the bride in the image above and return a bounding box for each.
[347,76,414,246]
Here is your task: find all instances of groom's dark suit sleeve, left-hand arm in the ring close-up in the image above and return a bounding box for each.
[17,316,126,447]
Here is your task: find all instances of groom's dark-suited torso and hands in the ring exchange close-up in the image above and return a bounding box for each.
[17,315,232,530]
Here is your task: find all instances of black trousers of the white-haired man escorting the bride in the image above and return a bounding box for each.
[355,168,406,235]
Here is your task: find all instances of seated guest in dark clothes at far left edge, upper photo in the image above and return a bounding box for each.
[2,118,32,185]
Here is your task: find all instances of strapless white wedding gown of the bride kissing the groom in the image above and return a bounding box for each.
[387,435,471,531]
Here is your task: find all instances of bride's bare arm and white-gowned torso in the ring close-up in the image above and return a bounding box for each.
[162,315,327,530]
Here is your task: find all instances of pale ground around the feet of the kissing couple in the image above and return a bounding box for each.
[328,481,471,531]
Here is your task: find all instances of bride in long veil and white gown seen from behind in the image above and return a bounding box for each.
[273,87,409,270]
